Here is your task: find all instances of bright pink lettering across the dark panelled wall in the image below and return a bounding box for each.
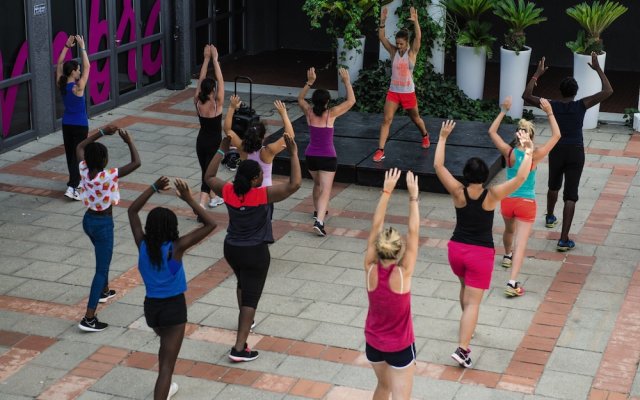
[0,0,162,137]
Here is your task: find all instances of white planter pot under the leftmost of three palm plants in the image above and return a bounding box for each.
[456,45,487,100]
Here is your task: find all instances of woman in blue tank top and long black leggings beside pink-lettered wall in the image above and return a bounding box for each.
[56,35,90,200]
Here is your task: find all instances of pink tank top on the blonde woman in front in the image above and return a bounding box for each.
[364,261,415,353]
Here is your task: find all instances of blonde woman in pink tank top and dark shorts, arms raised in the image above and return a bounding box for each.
[364,168,420,400]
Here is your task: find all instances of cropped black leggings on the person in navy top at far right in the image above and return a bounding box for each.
[548,144,584,201]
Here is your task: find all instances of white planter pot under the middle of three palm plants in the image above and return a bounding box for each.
[498,47,531,118]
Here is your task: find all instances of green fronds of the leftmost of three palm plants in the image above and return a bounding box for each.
[444,0,496,58]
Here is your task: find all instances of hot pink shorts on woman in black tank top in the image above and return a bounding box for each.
[447,240,496,290]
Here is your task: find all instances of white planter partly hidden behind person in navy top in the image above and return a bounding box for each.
[573,52,607,129]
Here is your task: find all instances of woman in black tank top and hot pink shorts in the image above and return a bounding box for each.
[433,121,533,368]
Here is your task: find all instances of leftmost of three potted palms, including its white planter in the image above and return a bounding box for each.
[444,0,496,99]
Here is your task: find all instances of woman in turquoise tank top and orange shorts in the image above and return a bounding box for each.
[489,97,560,297]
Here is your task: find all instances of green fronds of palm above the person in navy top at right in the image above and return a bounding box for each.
[567,0,628,55]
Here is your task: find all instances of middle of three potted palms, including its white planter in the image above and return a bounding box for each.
[493,0,547,118]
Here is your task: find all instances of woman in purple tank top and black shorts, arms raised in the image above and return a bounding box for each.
[298,68,356,236]
